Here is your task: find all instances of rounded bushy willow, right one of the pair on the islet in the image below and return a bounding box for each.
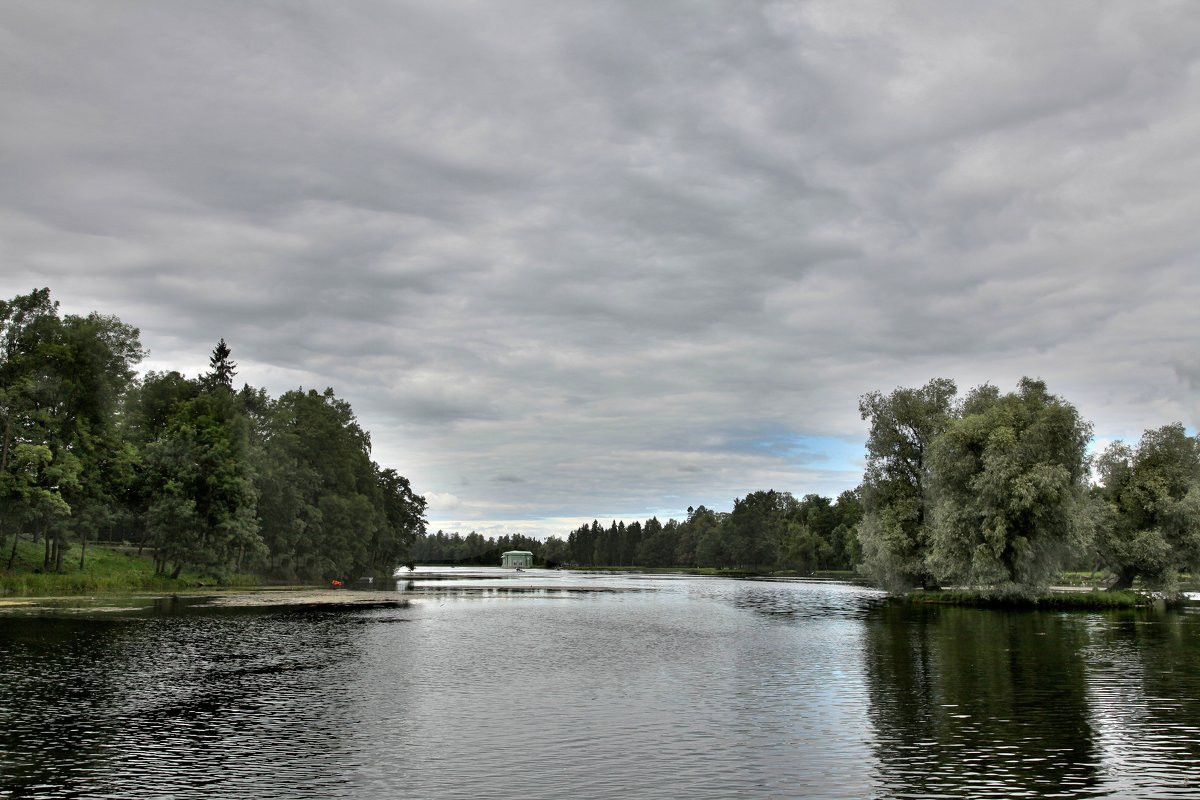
[929,378,1092,595]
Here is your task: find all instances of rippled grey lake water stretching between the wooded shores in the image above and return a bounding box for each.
[0,571,1200,800]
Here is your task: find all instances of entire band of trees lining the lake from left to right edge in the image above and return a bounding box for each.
[0,289,1200,597]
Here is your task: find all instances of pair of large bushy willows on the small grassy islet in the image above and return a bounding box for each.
[858,378,1096,597]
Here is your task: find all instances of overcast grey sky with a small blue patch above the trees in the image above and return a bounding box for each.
[0,0,1200,536]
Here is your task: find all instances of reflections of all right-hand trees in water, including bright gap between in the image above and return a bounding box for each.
[864,604,1200,798]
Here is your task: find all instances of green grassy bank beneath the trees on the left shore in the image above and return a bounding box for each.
[0,542,259,597]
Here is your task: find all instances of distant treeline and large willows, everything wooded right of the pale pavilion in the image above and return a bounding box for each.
[526,378,1200,599]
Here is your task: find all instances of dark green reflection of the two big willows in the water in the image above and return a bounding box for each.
[864,604,1104,798]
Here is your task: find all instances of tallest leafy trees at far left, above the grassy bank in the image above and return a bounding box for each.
[0,289,143,570]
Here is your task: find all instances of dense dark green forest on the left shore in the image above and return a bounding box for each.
[0,289,425,579]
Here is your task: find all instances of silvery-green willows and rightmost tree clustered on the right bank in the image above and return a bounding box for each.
[858,378,1200,599]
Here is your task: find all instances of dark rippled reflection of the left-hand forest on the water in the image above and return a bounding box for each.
[0,609,400,798]
